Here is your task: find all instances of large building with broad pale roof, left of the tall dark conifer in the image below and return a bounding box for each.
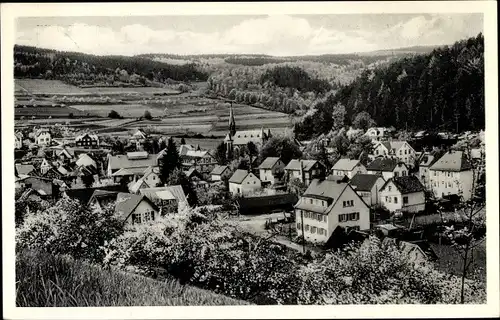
[107,151,158,177]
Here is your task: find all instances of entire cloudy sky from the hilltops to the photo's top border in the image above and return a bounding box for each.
[16,13,483,56]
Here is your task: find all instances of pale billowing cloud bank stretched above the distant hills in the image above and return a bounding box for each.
[17,15,477,55]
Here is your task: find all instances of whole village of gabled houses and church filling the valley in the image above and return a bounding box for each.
[15,104,485,260]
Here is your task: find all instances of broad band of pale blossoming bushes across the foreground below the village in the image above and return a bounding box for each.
[16,198,486,304]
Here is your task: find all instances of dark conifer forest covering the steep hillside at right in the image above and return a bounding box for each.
[295,34,485,137]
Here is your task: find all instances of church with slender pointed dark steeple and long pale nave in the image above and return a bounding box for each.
[224,103,271,152]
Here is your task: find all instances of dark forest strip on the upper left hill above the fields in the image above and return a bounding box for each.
[14,45,208,85]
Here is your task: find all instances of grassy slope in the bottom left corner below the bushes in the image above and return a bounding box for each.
[16,250,248,307]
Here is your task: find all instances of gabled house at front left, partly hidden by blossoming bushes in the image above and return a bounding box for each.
[115,192,160,224]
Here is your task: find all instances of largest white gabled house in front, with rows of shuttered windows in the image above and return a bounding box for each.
[295,179,370,243]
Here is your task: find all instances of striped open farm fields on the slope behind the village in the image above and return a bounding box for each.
[15,79,293,140]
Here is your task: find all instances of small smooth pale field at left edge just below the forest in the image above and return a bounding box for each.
[14,79,89,95]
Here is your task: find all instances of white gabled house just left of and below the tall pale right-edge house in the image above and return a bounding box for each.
[380,176,425,212]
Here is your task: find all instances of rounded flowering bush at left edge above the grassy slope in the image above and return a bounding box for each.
[16,197,122,261]
